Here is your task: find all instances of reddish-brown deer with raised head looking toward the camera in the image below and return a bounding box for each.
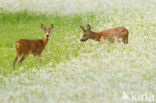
[13,24,53,68]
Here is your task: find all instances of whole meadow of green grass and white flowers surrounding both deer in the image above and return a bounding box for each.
[0,0,156,103]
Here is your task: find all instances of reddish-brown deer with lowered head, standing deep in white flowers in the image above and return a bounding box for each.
[80,24,128,44]
